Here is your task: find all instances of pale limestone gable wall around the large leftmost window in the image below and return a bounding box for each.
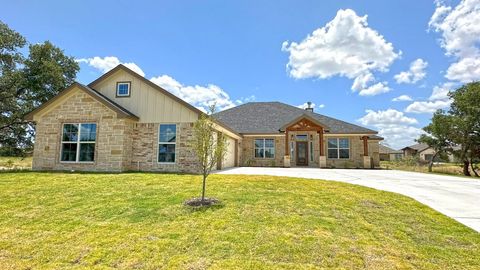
[32,90,133,171]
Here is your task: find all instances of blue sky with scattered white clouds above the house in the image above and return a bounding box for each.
[0,0,480,148]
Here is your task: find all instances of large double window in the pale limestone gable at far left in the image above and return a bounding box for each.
[60,123,97,162]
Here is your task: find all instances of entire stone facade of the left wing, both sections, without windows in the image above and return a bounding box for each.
[32,91,198,173]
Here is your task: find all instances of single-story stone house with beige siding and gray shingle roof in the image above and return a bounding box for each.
[26,65,382,172]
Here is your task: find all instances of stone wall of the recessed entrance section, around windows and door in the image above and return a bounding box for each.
[240,131,380,168]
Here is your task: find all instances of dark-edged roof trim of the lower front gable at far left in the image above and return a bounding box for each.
[24,82,138,120]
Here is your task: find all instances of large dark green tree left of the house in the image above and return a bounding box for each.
[0,21,80,155]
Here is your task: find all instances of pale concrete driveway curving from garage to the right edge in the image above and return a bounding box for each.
[216,167,480,232]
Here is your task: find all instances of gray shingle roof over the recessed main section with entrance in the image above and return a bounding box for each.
[214,102,377,134]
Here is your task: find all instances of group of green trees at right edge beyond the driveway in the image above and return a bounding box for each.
[417,82,480,177]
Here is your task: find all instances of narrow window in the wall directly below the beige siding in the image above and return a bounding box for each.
[158,124,177,163]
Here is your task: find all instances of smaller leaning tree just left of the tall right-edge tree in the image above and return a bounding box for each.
[417,110,453,172]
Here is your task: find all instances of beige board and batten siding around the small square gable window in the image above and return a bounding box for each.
[92,70,198,123]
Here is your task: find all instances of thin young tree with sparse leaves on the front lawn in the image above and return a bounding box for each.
[190,106,228,205]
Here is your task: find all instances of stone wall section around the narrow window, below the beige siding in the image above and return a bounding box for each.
[129,123,199,173]
